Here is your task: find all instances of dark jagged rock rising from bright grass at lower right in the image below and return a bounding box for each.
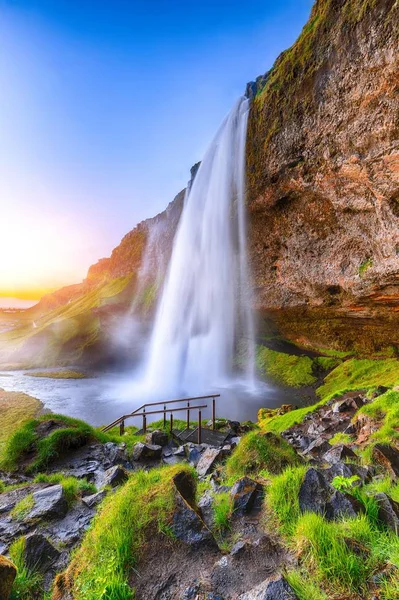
[299,468,363,521]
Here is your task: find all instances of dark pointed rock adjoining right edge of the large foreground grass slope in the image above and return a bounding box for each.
[172,494,215,546]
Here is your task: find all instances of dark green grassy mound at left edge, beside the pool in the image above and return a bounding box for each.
[0,414,110,472]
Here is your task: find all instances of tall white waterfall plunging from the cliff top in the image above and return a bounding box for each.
[144,98,254,393]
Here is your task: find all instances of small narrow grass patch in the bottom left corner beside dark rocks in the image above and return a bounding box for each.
[9,537,43,600]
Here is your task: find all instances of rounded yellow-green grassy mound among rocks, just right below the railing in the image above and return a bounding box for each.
[225,431,300,478]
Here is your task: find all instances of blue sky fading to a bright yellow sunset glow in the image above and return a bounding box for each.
[0,0,313,298]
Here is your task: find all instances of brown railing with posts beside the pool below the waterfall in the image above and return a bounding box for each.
[102,394,220,444]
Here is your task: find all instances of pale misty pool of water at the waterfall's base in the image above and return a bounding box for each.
[0,369,304,426]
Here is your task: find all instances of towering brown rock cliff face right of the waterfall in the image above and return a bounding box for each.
[247,0,399,350]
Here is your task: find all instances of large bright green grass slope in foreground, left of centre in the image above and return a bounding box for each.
[53,466,194,600]
